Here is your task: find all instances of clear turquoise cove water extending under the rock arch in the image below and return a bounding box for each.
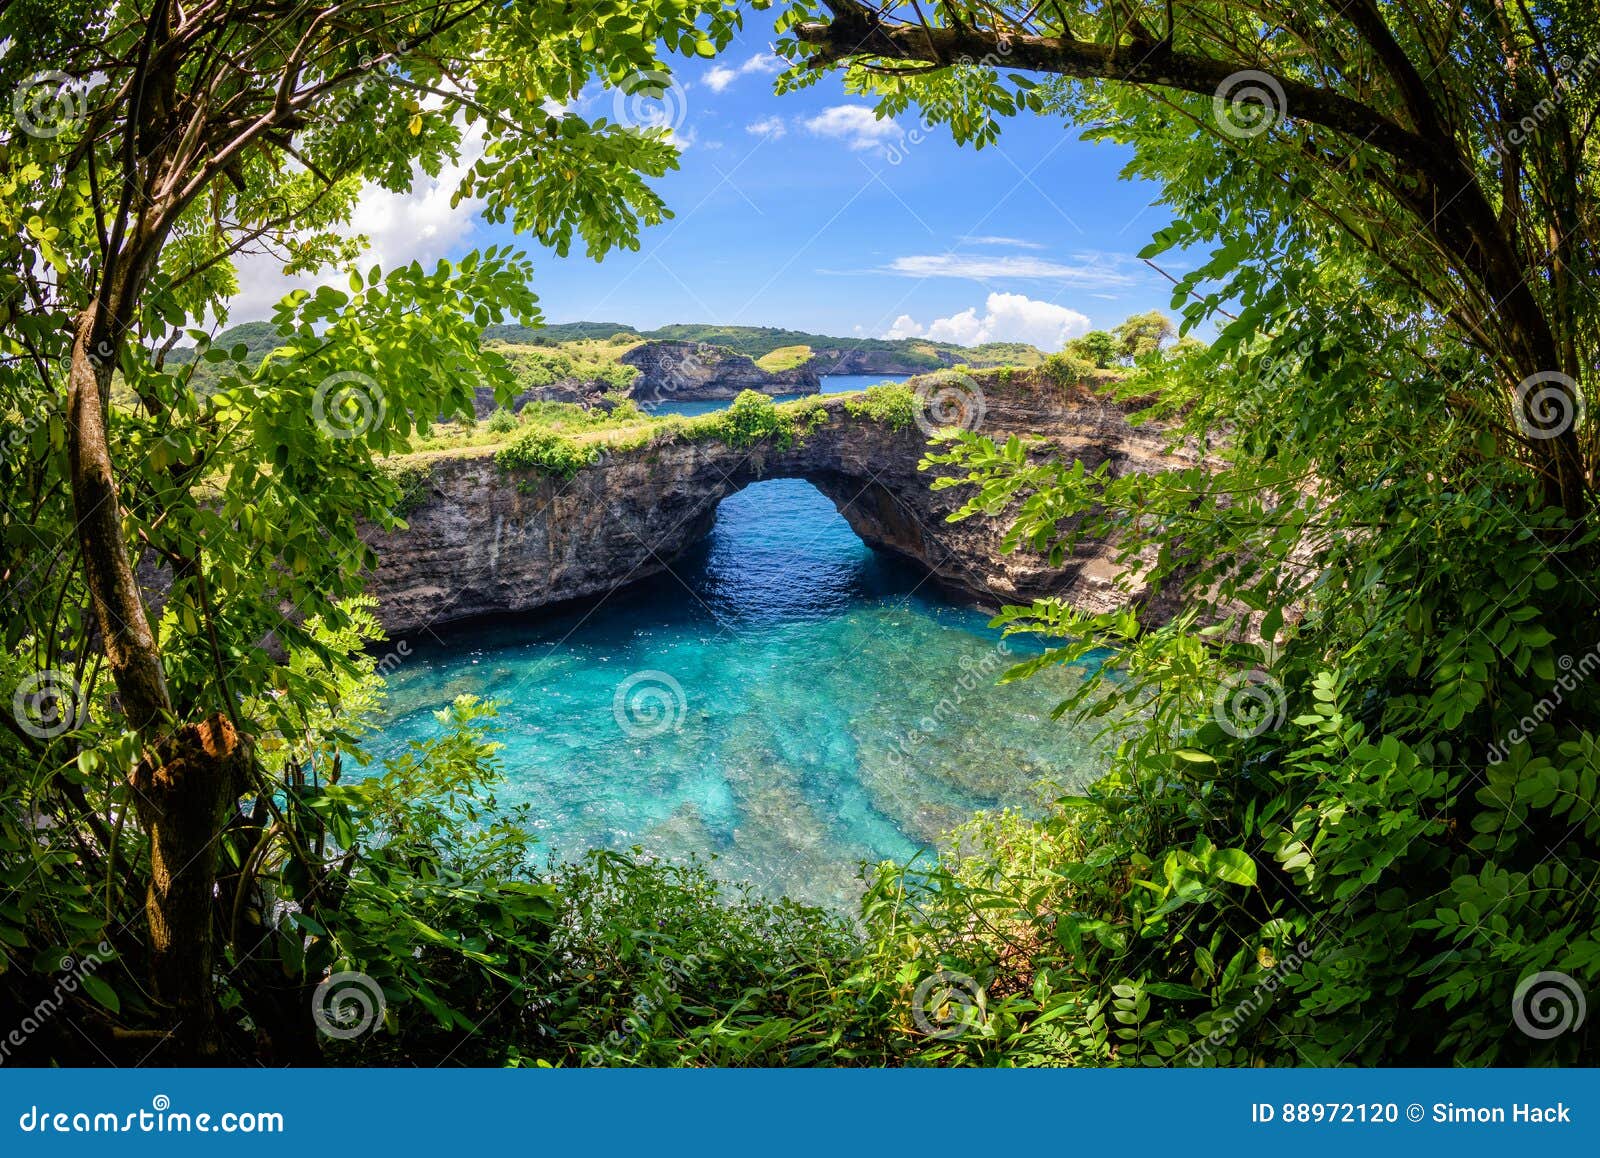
[370,375,1093,908]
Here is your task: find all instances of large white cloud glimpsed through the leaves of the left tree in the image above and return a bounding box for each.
[229,131,483,323]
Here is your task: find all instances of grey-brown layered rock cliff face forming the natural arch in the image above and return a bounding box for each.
[366,374,1178,637]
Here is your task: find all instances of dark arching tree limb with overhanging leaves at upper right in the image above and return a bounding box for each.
[786,0,1600,520]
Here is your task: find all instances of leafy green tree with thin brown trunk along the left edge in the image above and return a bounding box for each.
[0,0,761,1056]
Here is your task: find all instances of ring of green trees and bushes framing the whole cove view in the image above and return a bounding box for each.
[0,0,1600,1064]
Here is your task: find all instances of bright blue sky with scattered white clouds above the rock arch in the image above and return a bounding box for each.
[234,26,1170,347]
